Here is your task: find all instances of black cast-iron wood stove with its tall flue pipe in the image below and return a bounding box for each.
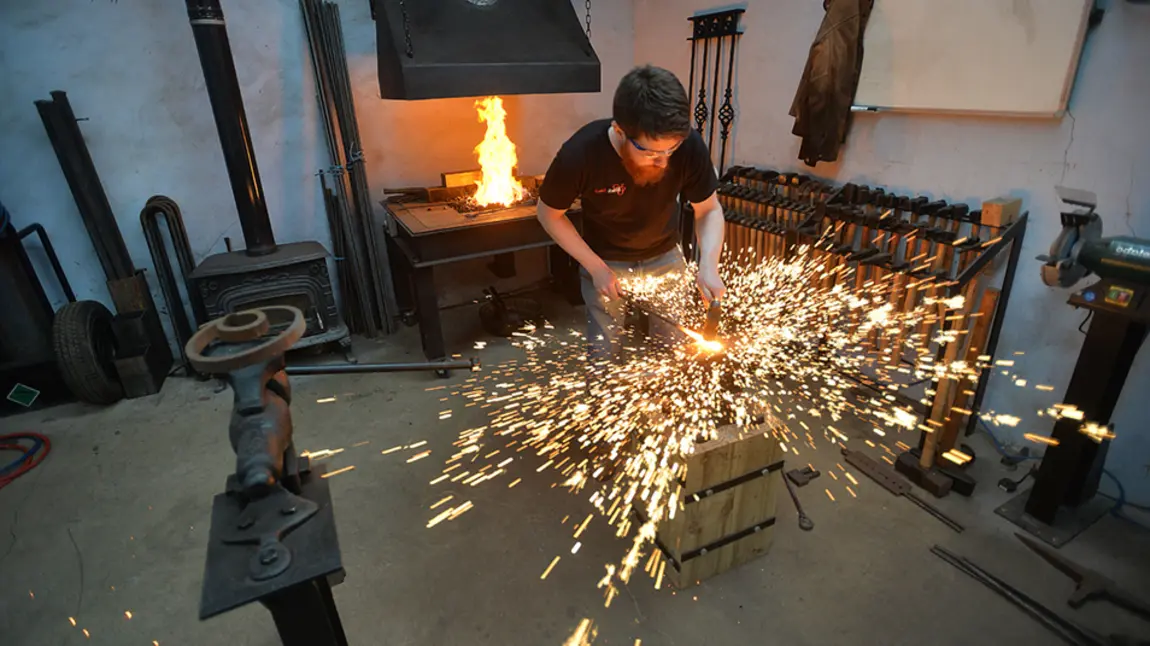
[180,0,351,349]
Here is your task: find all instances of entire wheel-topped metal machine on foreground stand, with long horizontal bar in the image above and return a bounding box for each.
[195,306,477,646]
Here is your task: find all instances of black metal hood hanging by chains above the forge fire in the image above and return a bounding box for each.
[374,0,599,100]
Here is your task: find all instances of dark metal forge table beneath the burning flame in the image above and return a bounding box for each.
[382,200,582,361]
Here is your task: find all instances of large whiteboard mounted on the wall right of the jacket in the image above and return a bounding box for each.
[854,0,1094,116]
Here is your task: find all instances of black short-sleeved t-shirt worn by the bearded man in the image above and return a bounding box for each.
[539,118,719,261]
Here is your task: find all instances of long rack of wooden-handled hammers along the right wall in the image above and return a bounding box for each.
[718,166,1027,493]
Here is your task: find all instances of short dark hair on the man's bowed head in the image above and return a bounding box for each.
[612,66,691,138]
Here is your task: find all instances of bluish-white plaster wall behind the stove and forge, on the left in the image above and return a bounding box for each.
[0,0,633,314]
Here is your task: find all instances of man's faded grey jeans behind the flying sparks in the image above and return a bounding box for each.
[580,247,687,362]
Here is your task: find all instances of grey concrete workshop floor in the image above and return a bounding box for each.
[0,296,1150,646]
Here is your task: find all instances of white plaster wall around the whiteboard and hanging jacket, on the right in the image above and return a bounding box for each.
[635,0,1150,502]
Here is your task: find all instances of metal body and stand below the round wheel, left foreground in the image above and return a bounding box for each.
[200,355,347,646]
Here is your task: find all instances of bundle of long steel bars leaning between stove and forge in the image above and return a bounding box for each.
[300,0,399,337]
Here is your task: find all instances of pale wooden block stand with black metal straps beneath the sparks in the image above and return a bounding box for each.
[657,424,783,589]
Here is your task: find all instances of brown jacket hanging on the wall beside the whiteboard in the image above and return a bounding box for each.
[790,0,874,166]
